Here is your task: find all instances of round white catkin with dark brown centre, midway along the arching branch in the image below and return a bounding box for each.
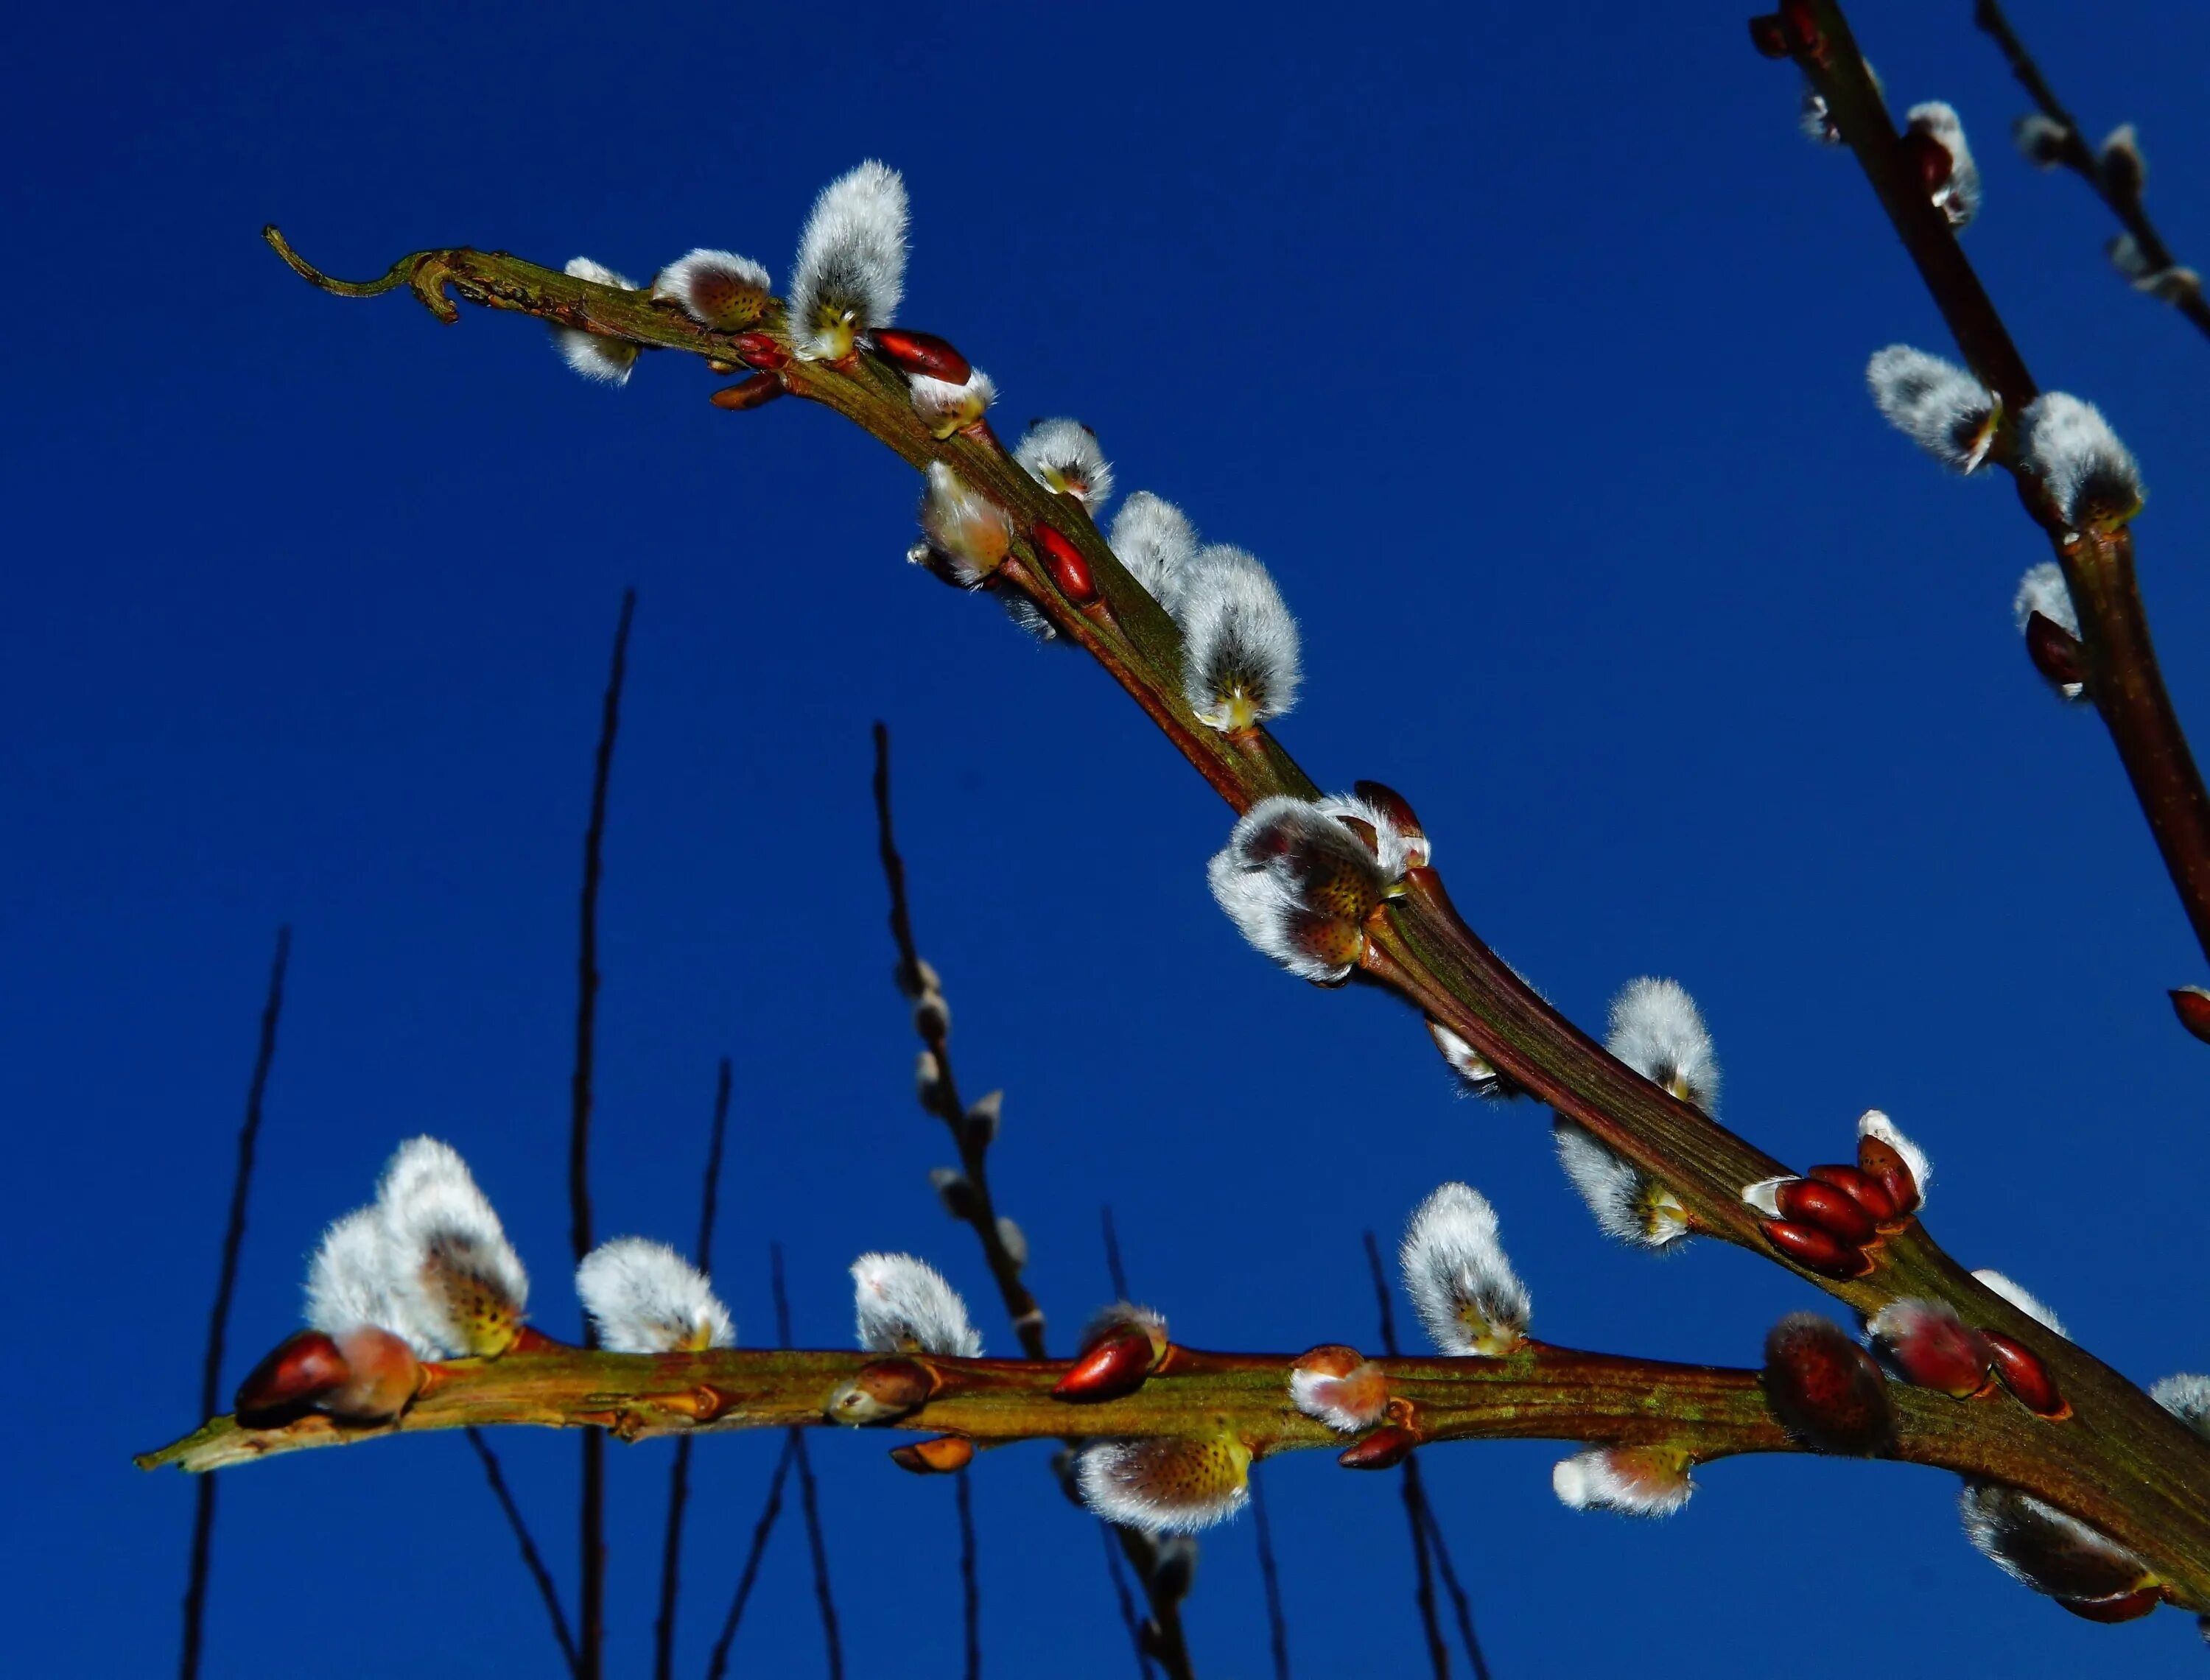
[1204,793,1388,986]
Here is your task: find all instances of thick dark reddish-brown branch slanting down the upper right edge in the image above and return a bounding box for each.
[1801,0,2210,972]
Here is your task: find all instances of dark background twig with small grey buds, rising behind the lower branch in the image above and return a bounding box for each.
[873,718,1193,1680]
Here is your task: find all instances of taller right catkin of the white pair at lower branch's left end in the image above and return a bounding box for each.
[376,1139,530,1353]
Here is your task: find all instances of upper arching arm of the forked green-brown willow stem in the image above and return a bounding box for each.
[267,223,2210,1609]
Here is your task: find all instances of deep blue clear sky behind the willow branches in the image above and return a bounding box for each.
[0,0,2210,1680]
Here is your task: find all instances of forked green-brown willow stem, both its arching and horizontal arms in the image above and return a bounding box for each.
[246,223,2210,1609]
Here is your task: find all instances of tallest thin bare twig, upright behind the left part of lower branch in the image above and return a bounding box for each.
[568,590,636,1680]
